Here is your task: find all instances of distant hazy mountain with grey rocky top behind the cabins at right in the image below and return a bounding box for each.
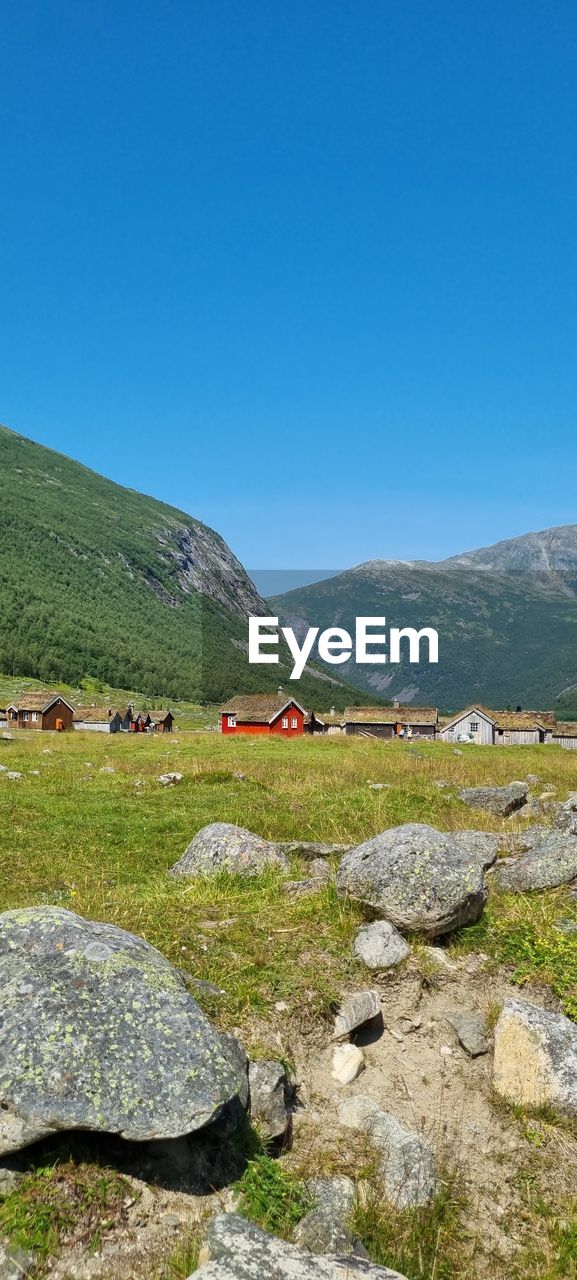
[269,542,577,716]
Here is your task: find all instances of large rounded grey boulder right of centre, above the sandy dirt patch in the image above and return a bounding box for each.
[336,822,487,938]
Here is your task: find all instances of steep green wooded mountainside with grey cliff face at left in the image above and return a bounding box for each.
[0,428,360,707]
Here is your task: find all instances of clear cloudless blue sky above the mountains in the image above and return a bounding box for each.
[0,0,577,568]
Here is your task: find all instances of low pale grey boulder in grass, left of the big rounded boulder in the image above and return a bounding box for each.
[170,822,288,877]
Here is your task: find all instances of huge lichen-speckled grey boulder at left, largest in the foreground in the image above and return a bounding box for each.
[0,906,248,1155]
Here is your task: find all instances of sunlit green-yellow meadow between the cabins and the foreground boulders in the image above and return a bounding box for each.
[0,731,577,1020]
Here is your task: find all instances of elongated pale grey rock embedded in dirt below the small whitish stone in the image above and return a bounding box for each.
[338,1093,436,1208]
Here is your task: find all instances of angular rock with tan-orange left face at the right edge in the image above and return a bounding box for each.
[493,1000,577,1116]
